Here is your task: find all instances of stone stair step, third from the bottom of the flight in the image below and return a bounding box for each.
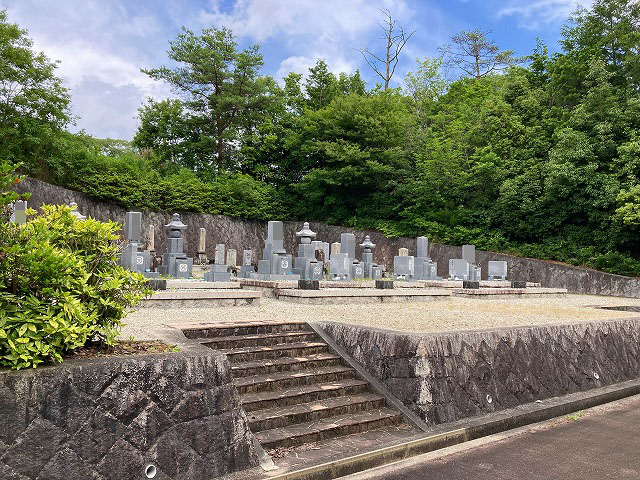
[240,378,369,412]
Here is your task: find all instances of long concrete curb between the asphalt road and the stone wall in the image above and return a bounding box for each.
[267,379,640,480]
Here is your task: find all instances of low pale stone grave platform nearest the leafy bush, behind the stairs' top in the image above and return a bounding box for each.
[138,288,262,309]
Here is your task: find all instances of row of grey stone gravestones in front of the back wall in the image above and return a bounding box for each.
[11,200,507,282]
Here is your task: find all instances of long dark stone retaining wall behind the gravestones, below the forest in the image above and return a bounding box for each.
[17,178,640,298]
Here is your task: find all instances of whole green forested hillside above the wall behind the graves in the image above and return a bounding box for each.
[0,0,640,275]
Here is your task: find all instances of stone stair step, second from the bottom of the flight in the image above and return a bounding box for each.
[248,392,385,433]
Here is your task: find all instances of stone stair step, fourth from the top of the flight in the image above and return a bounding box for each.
[231,352,340,378]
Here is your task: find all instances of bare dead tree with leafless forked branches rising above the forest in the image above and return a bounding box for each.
[356,9,416,90]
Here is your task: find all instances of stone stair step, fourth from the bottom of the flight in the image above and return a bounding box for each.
[234,365,355,395]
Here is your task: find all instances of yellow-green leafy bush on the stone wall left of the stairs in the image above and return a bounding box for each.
[0,206,147,369]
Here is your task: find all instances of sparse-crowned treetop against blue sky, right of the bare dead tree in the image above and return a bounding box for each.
[440,29,522,78]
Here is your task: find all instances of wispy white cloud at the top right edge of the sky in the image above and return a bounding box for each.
[498,0,593,30]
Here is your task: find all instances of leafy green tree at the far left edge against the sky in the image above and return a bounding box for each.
[0,10,71,172]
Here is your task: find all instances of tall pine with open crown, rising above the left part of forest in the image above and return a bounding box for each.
[142,27,276,172]
